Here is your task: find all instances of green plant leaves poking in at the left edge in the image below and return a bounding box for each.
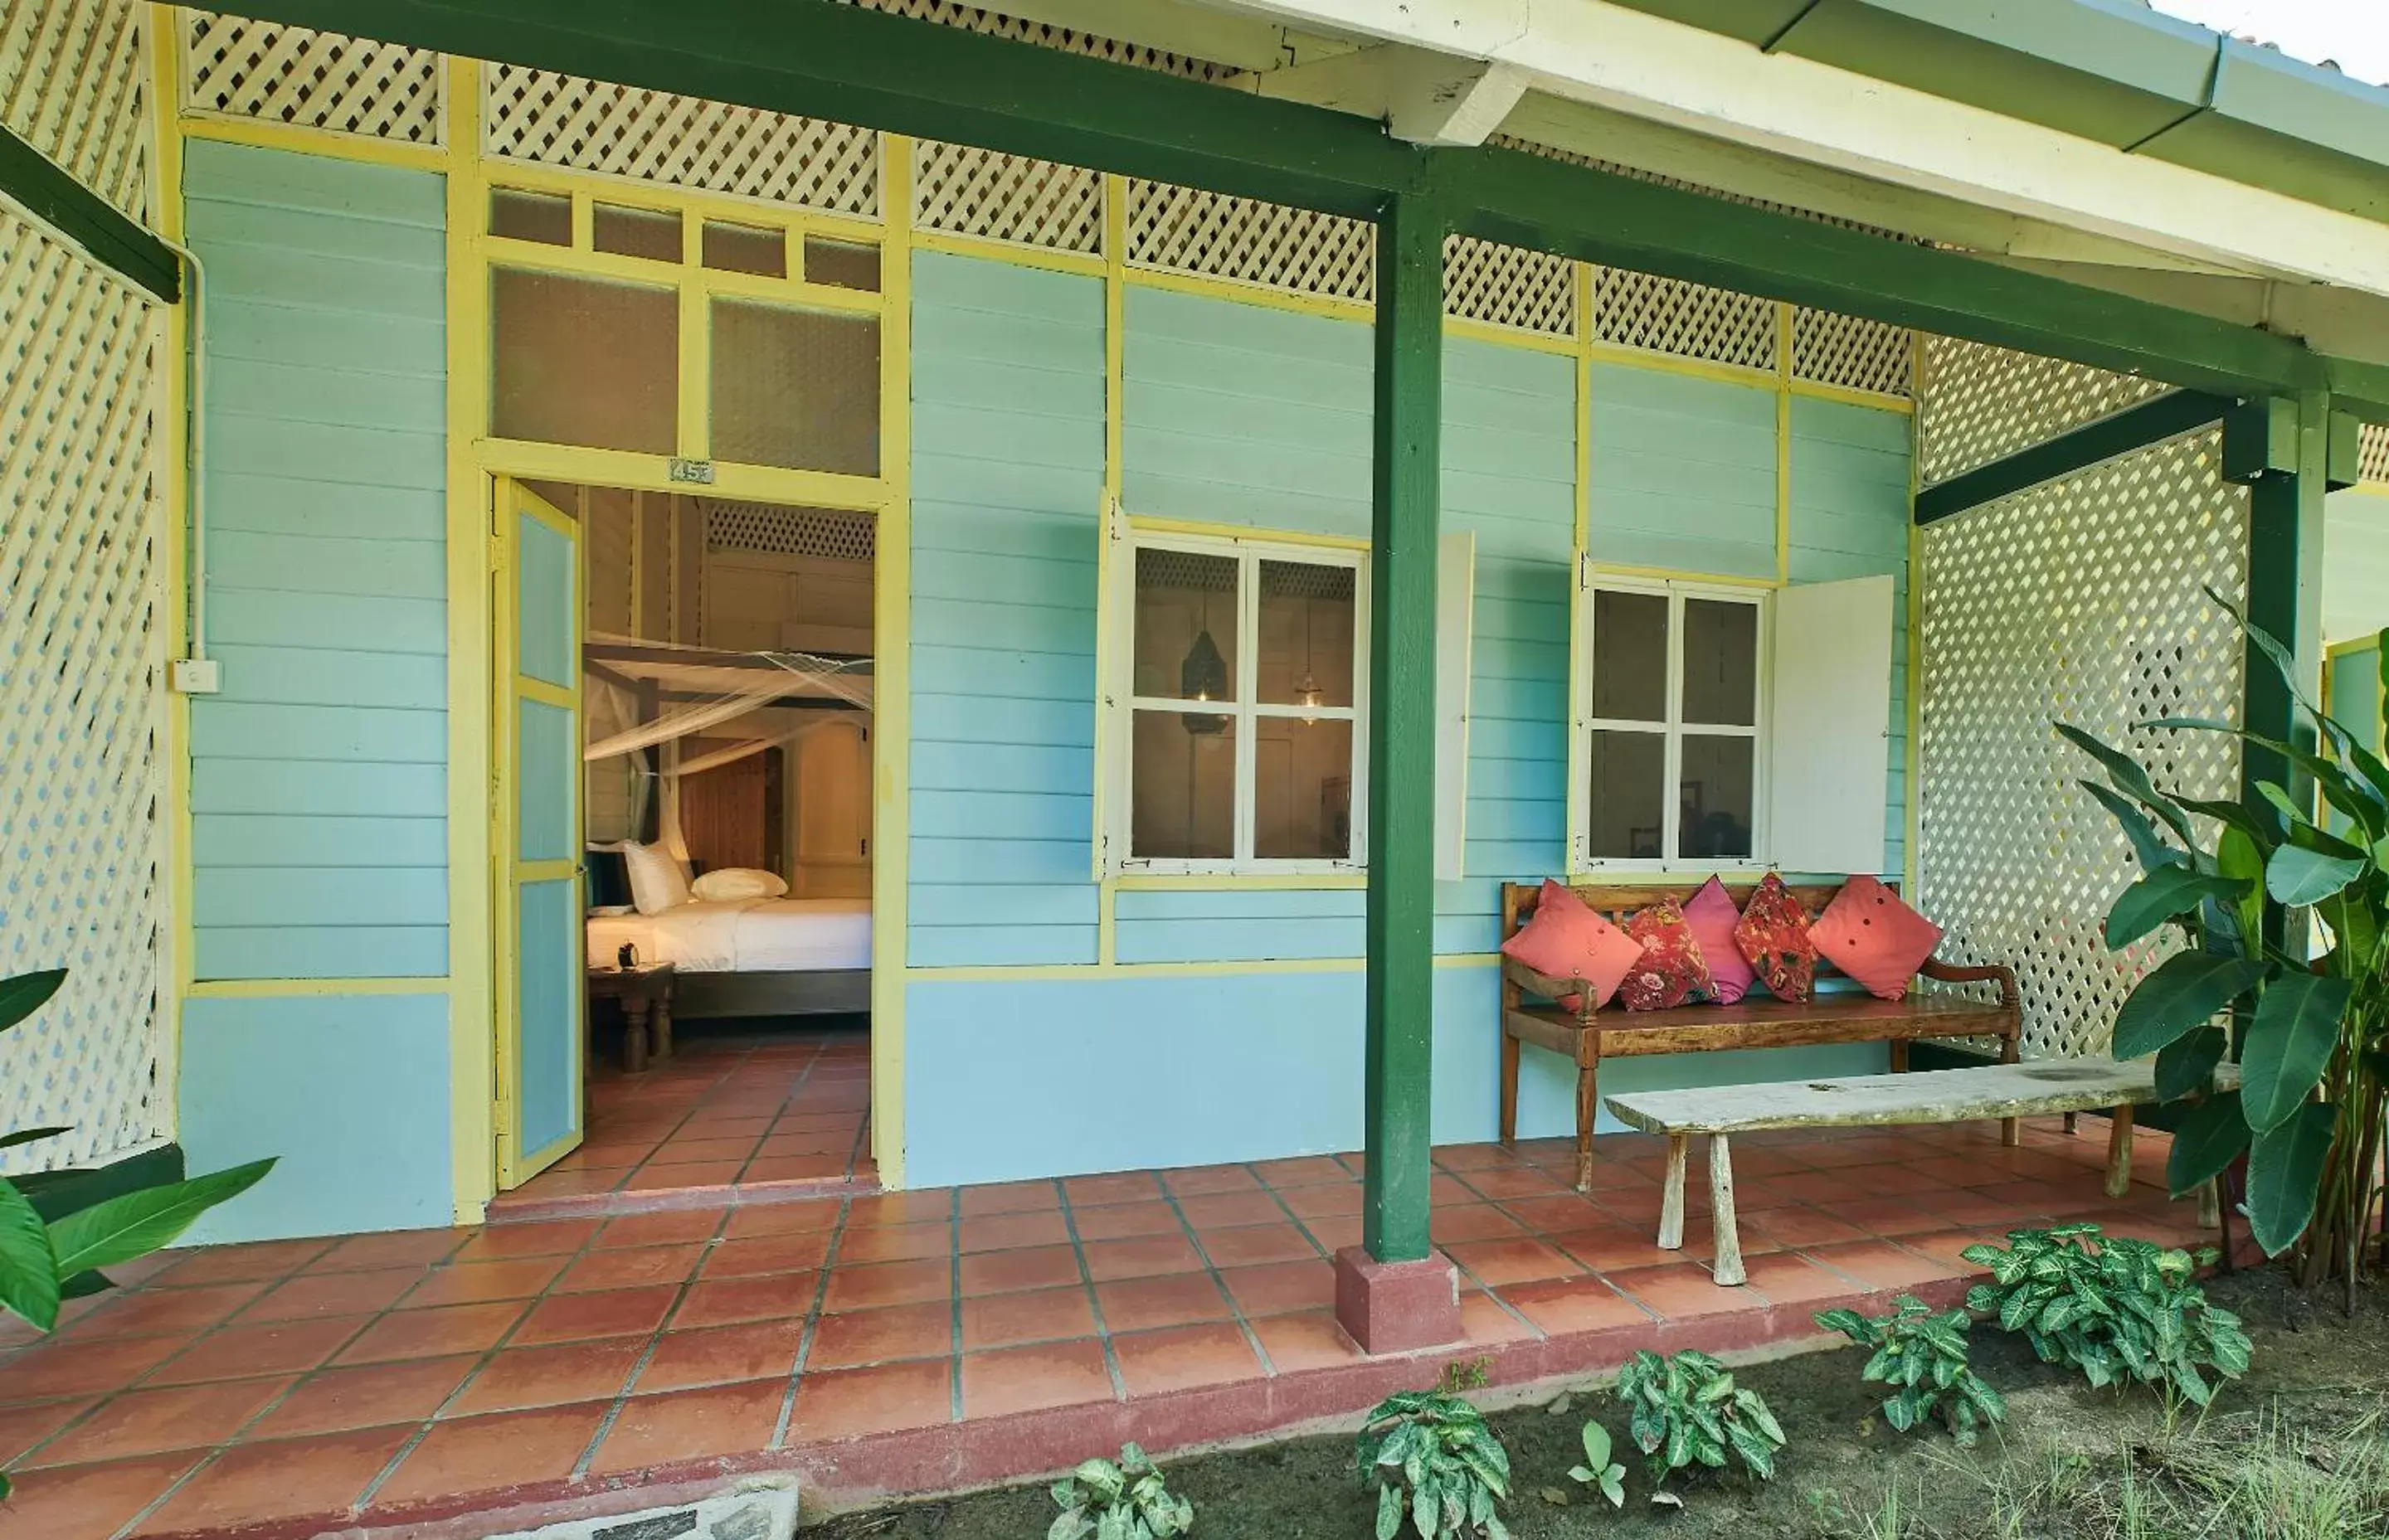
[0,969,275,1499]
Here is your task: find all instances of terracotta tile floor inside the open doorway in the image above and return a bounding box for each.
[489,1027,879,1220]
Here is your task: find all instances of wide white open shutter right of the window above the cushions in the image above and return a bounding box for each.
[1768,578,1892,874]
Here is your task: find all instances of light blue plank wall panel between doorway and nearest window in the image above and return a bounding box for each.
[906,253,1104,967]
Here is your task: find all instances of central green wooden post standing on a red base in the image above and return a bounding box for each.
[1362,193,1448,1263]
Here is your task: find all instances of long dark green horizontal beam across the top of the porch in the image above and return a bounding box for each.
[228,0,2389,423]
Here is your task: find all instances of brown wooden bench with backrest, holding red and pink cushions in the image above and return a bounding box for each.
[1501,878,2023,1192]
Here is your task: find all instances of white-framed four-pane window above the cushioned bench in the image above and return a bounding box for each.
[1569,571,1773,872]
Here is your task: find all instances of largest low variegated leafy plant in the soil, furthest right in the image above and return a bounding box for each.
[1963,1225,2248,1406]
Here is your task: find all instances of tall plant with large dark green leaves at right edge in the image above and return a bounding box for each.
[2057,590,2389,1309]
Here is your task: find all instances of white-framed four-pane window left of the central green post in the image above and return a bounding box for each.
[1104,521,1369,874]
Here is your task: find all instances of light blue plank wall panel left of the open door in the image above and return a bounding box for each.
[184,141,447,979]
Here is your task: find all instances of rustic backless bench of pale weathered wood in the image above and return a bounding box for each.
[1608,1057,2239,1285]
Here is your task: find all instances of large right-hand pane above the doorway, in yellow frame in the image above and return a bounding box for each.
[712,299,879,475]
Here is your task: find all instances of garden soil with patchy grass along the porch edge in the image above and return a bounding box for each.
[805,1268,2389,1540]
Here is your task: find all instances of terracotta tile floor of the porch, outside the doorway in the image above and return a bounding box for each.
[0,1117,2198,1540]
